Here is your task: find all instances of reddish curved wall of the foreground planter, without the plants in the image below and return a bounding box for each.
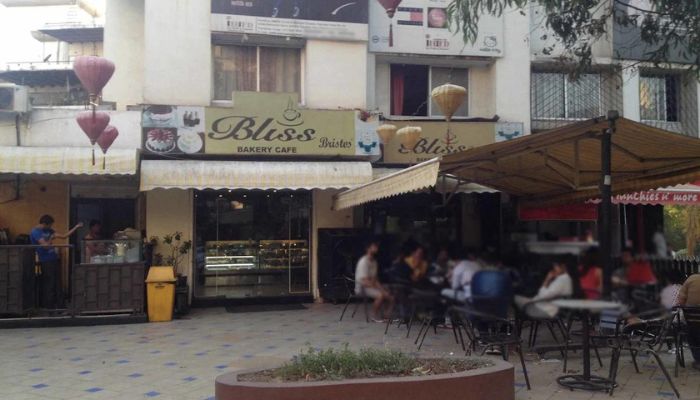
[216,360,515,400]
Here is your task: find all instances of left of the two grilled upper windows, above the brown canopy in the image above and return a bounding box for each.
[531,72,602,119]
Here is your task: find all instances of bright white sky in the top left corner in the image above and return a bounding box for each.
[0,0,104,70]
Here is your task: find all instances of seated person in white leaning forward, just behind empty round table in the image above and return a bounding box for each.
[515,262,574,318]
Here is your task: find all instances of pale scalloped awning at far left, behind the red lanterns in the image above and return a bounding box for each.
[0,146,139,175]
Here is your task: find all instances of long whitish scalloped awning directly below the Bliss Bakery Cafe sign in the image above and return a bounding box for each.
[141,160,372,191]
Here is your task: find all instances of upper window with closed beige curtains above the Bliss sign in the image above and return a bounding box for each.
[213,46,301,100]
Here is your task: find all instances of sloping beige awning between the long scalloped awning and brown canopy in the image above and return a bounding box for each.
[333,158,440,210]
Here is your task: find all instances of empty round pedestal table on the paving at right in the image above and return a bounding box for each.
[552,299,622,391]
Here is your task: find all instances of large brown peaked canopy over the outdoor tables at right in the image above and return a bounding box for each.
[440,117,700,205]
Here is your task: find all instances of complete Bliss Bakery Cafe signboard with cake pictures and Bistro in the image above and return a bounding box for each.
[142,92,381,157]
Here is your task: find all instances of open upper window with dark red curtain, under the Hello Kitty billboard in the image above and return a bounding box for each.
[390,64,469,117]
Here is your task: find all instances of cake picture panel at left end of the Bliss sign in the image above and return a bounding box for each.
[141,105,205,154]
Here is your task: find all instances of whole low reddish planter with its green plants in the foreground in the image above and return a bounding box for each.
[216,346,515,400]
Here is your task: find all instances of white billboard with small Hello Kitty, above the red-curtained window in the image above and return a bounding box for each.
[369,0,503,57]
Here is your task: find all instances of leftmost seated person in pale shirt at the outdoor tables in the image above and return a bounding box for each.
[355,241,394,321]
